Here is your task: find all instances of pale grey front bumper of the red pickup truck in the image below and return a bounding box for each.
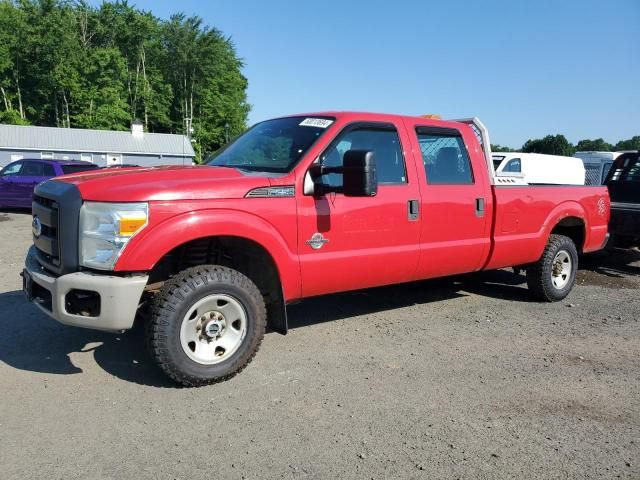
[23,247,149,332]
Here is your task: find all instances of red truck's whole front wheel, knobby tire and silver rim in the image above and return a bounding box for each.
[147,265,267,387]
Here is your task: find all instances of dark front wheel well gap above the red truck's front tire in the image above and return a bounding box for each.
[147,236,287,333]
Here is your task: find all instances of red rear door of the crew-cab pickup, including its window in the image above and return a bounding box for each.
[410,123,491,278]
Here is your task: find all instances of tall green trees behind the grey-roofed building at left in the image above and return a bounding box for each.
[0,0,250,158]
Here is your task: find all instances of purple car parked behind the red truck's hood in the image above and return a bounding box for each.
[0,158,98,208]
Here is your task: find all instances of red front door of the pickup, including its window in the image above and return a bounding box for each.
[298,122,420,297]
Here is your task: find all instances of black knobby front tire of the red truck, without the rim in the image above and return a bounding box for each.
[145,265,267,387]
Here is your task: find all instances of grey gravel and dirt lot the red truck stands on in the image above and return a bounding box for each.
[0,213,640,479]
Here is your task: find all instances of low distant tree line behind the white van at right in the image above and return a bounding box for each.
[491,135,640,157]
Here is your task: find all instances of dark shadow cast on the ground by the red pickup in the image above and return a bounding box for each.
[0,272,528,388]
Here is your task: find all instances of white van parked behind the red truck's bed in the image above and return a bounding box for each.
[492,152,585,185]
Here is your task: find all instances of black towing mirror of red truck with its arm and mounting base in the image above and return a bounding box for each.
[304,150,378,197]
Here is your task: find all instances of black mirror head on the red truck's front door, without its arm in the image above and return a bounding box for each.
[342,150,378,197]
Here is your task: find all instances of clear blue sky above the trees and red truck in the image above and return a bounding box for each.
[94,0,640,147]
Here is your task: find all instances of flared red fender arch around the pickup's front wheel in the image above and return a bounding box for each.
[114,209,301,301]
